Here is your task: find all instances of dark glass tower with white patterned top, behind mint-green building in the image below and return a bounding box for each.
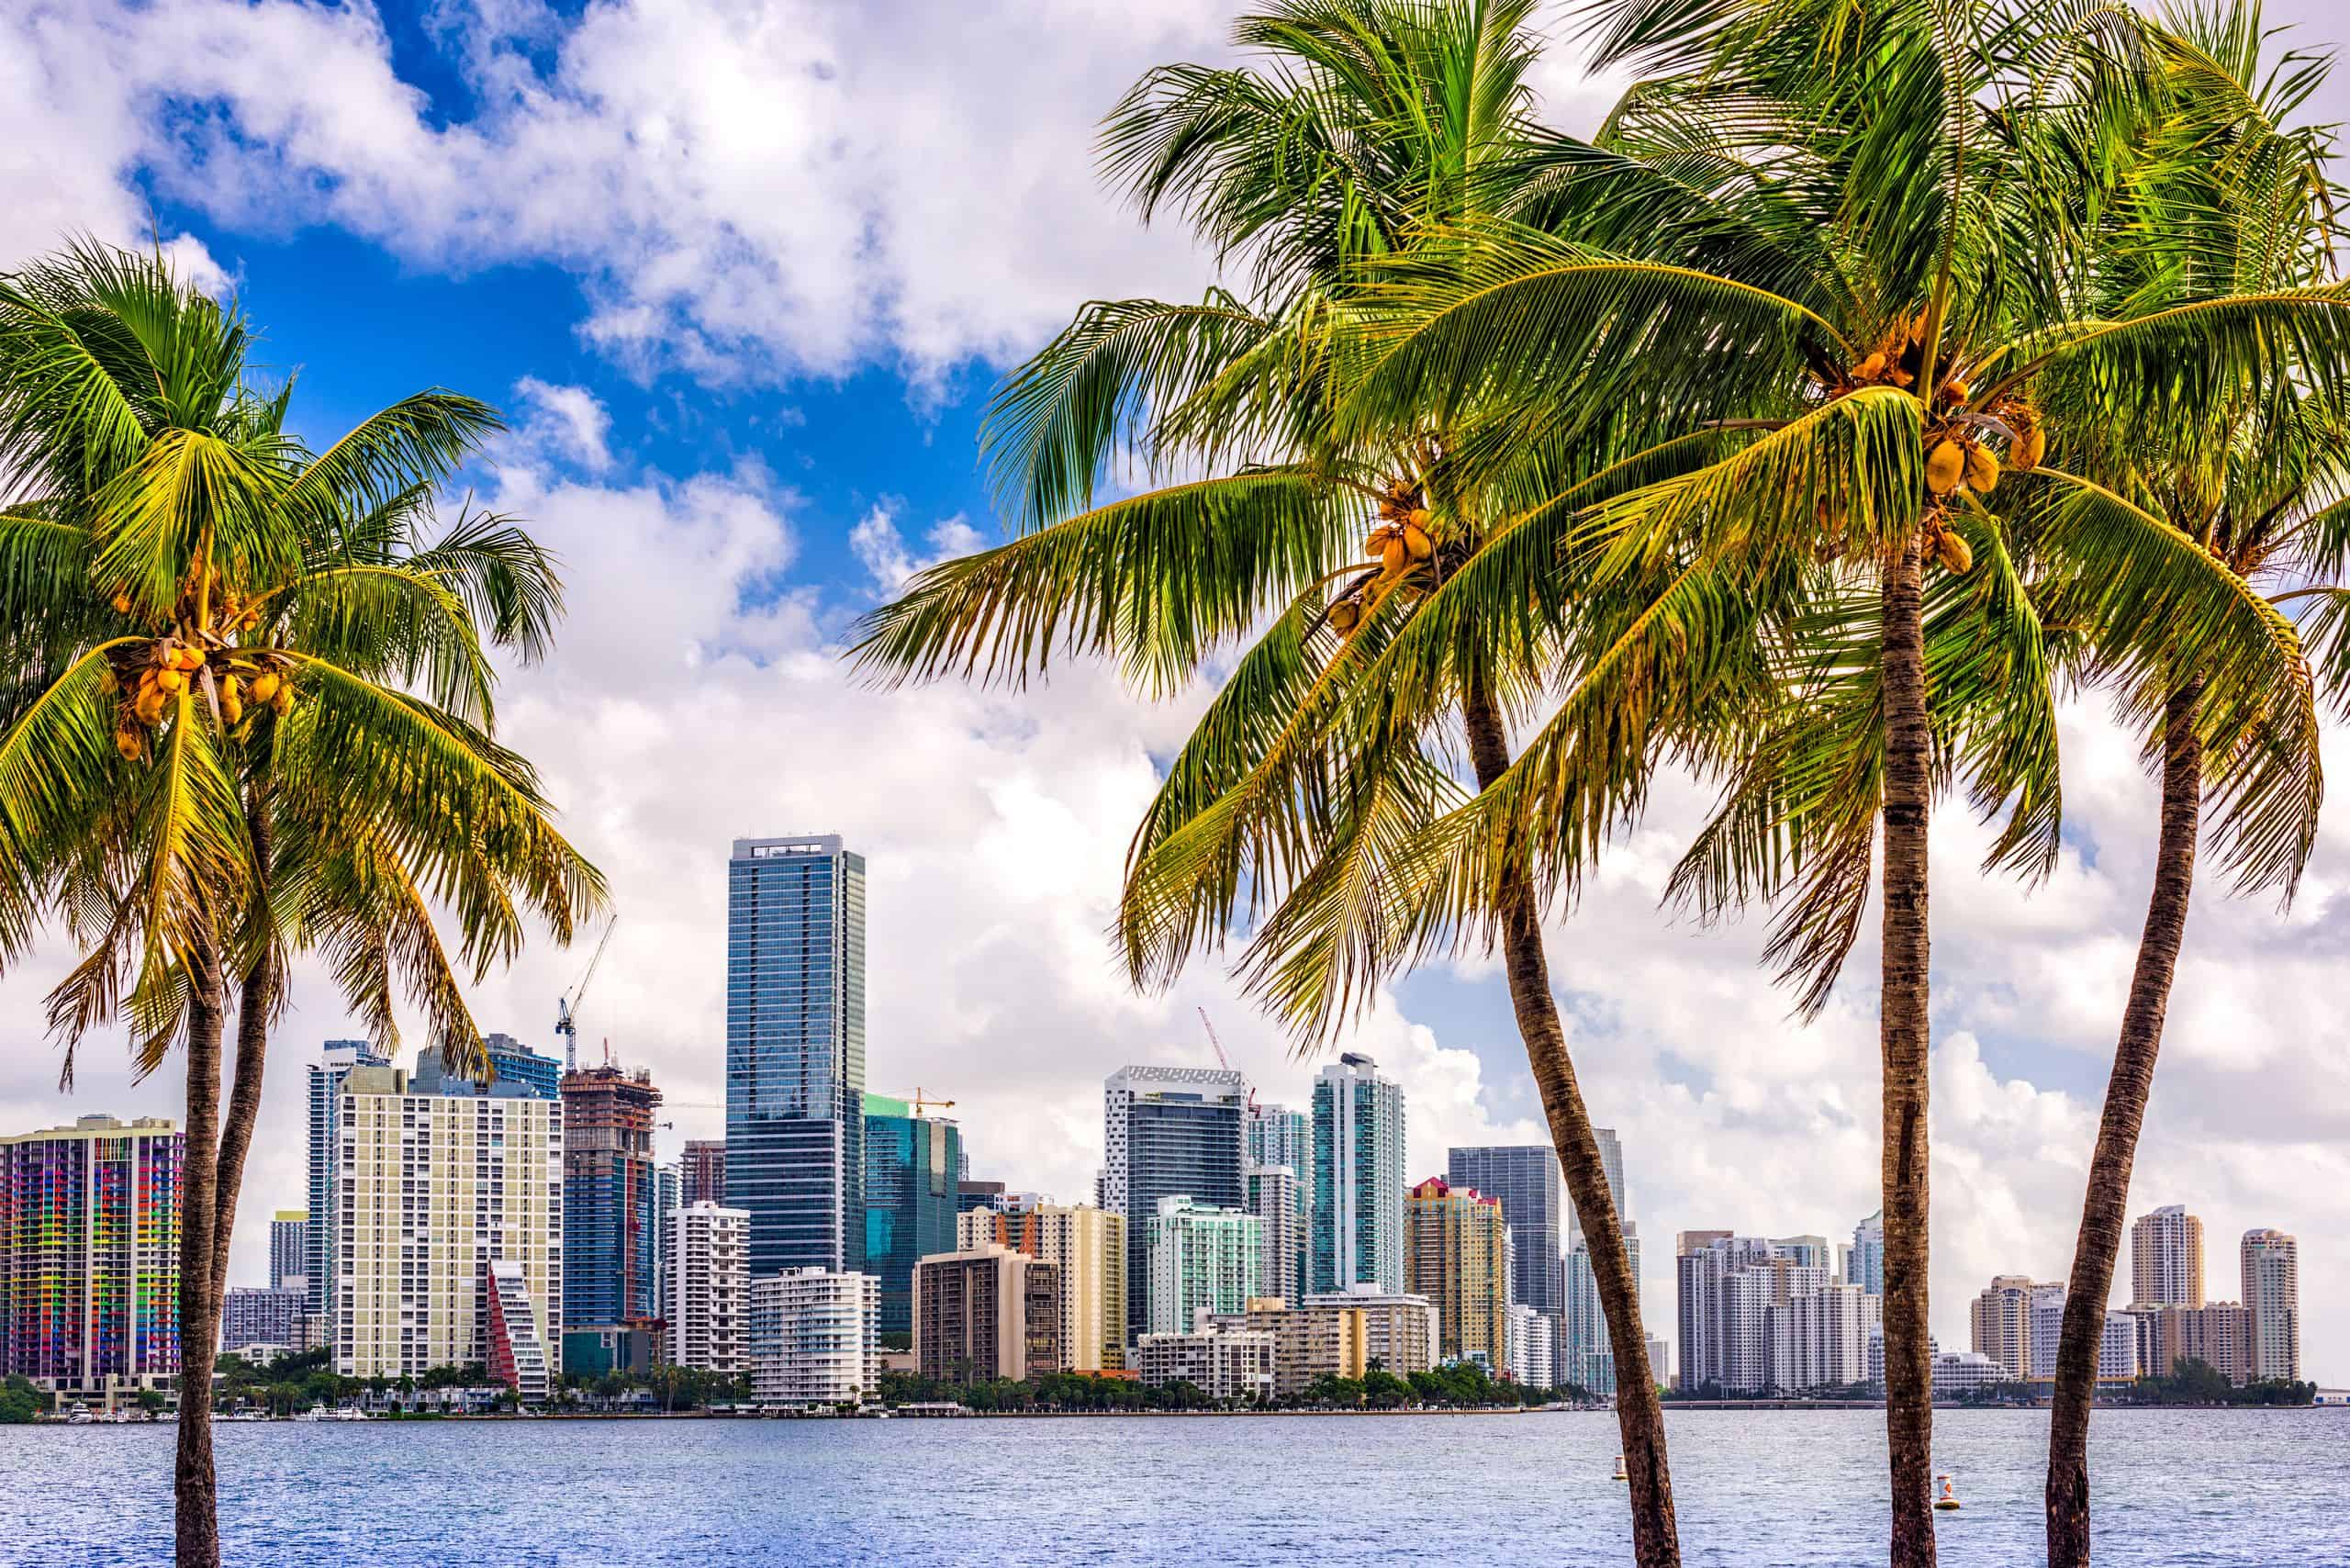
[1100,1068,1249,1340]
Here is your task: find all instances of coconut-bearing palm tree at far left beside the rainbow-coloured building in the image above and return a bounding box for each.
[0,244,601,1568]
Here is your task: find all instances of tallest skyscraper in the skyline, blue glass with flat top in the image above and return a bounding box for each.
[726,834,865,1274]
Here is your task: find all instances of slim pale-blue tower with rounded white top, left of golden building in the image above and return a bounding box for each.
[1314,1051,1403,1295]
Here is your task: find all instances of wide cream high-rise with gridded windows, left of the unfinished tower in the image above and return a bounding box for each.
[331,1068,564,1378]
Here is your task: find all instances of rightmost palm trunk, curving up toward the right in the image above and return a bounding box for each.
[2047,679,2202,1568]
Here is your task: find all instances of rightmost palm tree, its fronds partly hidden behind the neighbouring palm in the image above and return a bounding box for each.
[2047,5,2350,1568]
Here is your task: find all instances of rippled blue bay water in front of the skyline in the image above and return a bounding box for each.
[0,1410,2350,1568]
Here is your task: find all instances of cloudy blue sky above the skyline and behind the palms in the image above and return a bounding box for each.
[0,0,2350,1375]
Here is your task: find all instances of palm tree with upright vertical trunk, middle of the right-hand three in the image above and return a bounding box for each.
[1335,0,2350,1568]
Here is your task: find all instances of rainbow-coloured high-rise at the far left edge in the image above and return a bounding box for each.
[0,1116,185,1404]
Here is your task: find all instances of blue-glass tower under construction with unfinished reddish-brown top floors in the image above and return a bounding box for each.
[562,1068,660,1344]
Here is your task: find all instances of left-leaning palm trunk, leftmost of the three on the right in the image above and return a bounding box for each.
[1461,675,1680,1568]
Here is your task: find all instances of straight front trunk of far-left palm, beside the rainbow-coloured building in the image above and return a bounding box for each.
[172,940,223,1568]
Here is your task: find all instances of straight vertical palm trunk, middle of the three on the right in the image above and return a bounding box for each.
[1877,529,1934,1568]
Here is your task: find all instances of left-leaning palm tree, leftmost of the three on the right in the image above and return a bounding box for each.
[856,0,1708,1563]
